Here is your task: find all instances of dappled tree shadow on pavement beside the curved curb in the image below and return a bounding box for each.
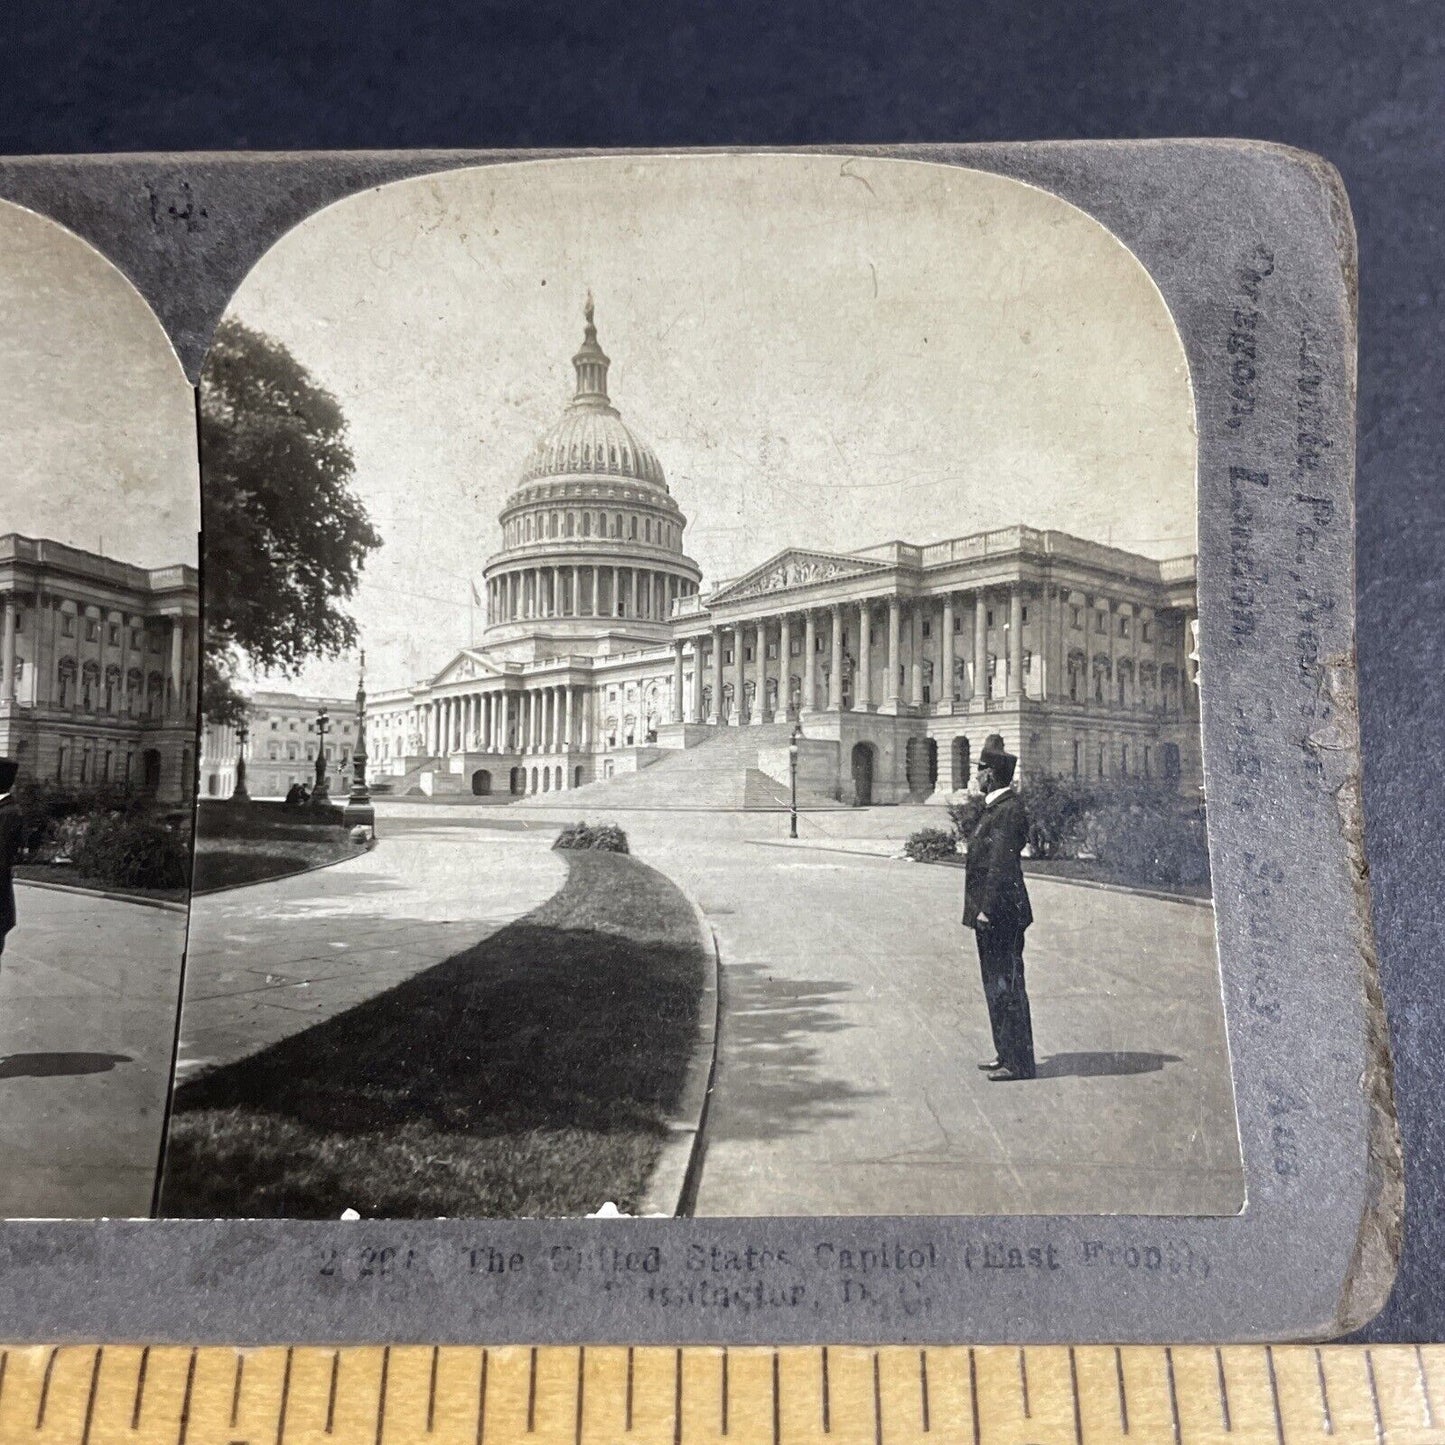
[708,964,876,1143]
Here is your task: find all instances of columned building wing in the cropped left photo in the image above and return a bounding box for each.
[0,532,199,802]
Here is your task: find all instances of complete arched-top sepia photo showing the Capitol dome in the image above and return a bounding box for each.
[158,153,1244,1218]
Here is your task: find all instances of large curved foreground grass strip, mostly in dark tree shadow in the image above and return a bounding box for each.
[160,853,711,1220]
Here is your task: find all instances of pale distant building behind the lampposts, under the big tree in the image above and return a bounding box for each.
[201,692,357,801]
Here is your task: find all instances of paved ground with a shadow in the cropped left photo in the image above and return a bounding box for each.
[0,883,185,1218]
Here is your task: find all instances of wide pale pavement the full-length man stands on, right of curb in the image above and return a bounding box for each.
[507,805,1243,1215]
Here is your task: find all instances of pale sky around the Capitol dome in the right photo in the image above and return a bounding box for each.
[231,155,1195,695]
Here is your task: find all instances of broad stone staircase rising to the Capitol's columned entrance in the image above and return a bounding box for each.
[540,723,844,812]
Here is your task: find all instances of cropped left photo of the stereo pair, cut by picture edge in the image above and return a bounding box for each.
[0,202,201,1218]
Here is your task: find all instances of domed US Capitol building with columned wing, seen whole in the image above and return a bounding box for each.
[367,301,1202,806]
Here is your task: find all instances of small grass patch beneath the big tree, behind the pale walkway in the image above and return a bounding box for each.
[191,801,366,893]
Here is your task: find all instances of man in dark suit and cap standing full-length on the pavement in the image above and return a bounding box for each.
[964,737,1035,1084]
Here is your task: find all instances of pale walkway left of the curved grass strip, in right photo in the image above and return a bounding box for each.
[176,811,566,1082]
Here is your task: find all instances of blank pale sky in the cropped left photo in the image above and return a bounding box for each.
[0,201,201,566]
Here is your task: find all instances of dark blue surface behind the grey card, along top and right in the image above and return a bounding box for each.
[0,0,1445,1340]
